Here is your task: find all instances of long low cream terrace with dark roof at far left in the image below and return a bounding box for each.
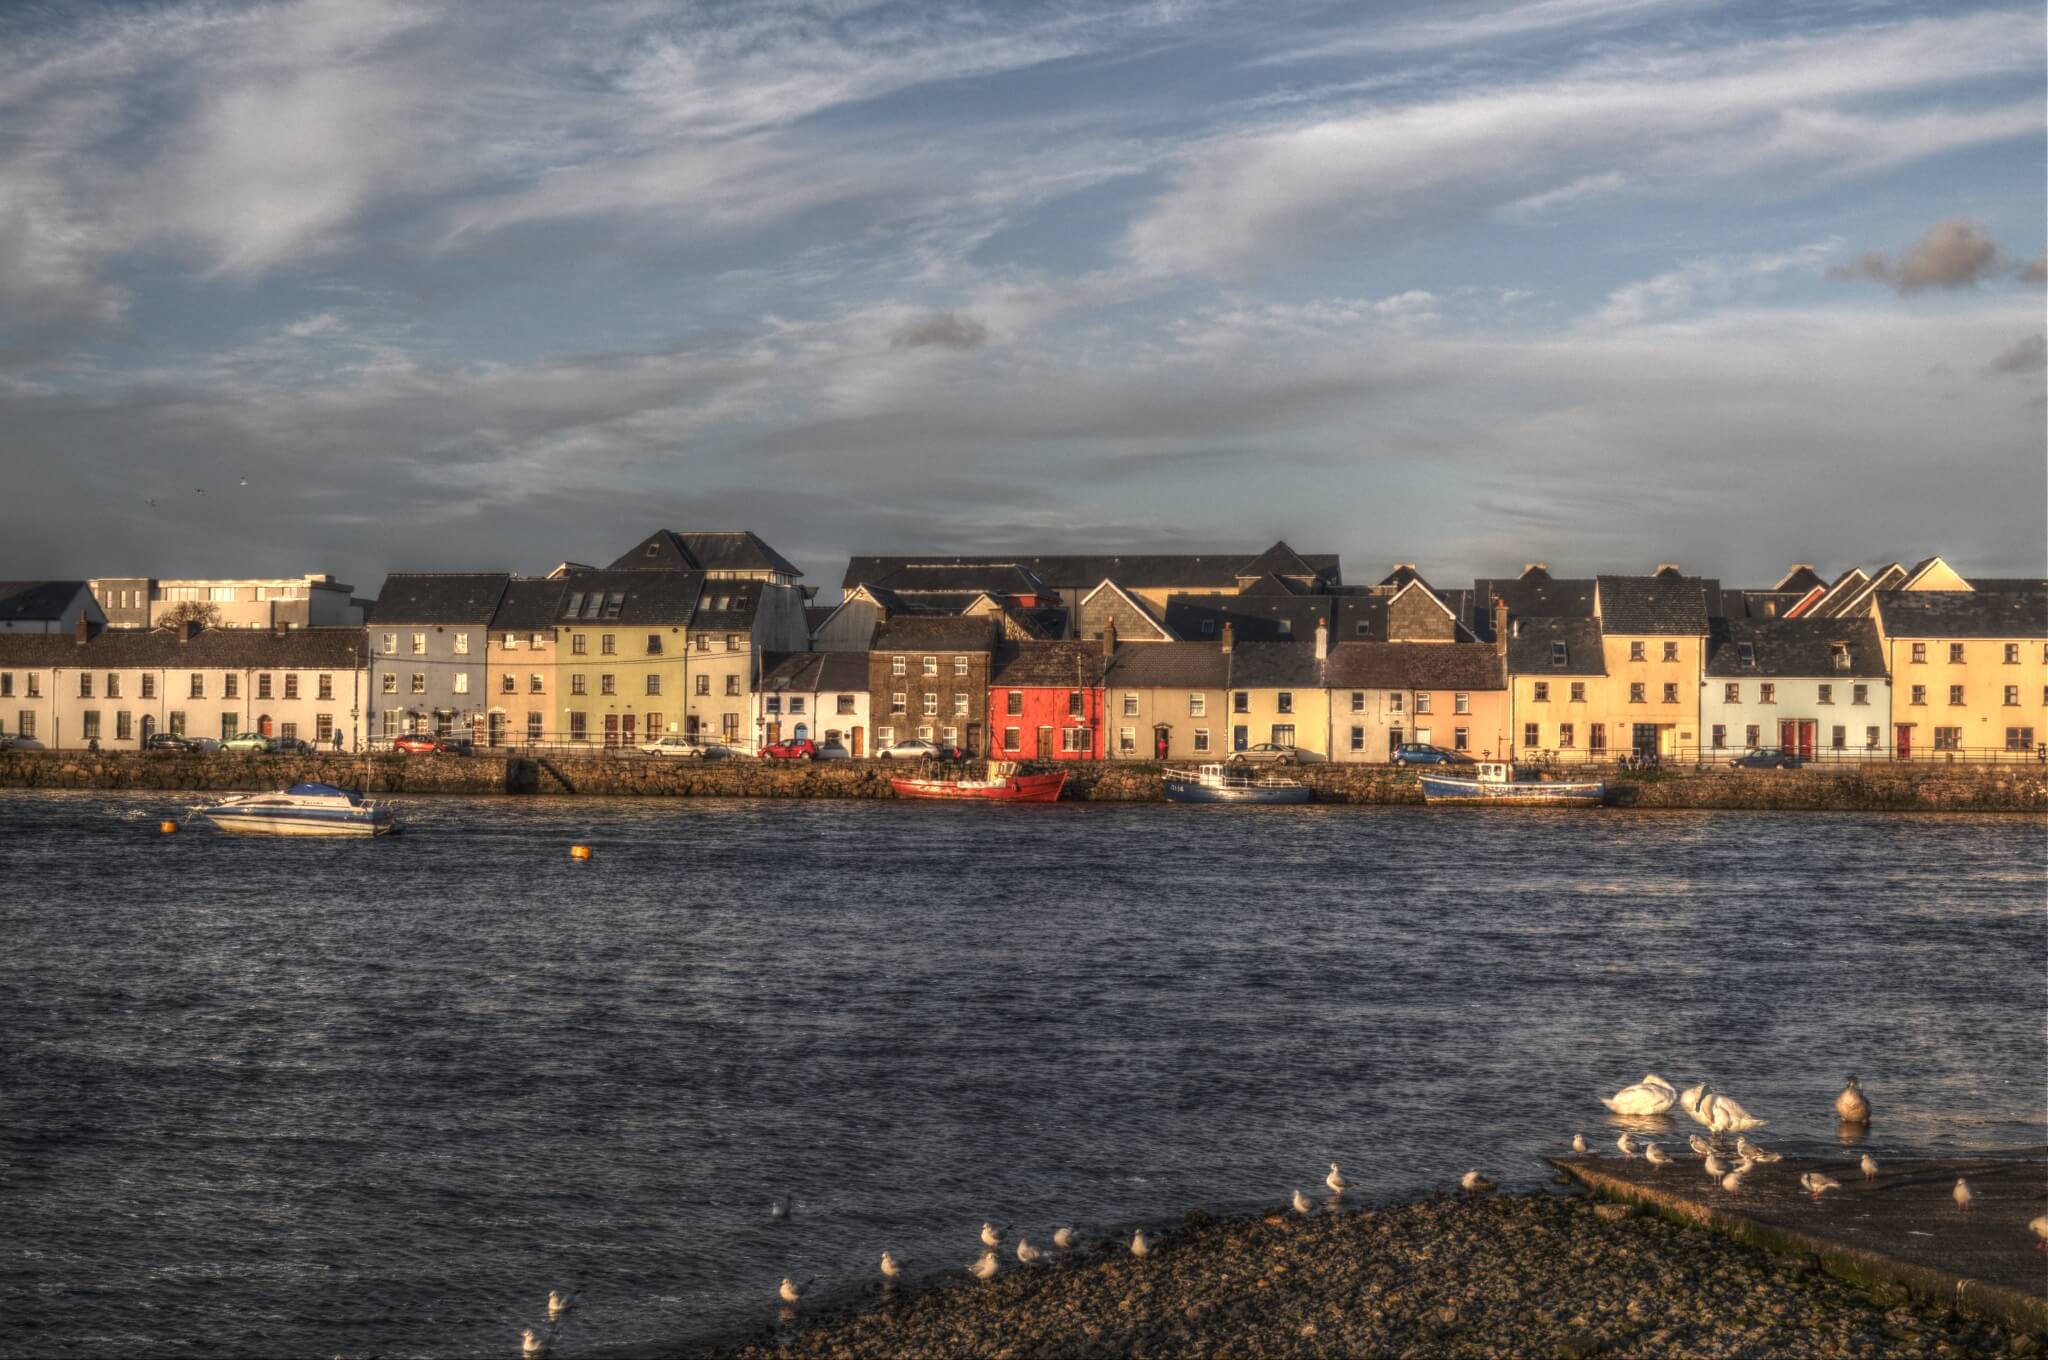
[0,625,369,752]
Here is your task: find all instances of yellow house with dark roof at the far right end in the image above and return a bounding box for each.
[1876,590,2048,760]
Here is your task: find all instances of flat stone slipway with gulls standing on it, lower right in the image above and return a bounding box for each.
[1550,1153,2048,1333]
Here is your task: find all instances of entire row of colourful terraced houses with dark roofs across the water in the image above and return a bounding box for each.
[0,530,2048,762]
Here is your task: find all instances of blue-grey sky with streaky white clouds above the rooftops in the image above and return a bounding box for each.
[0,0,2048,598]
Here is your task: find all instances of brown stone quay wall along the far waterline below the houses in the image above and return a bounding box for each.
[0,750,2048,815]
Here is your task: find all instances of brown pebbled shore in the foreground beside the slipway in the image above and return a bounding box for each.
[715,1194,2040,1360]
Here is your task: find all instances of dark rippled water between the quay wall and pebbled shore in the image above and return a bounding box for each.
[0,795,2048,1356]
